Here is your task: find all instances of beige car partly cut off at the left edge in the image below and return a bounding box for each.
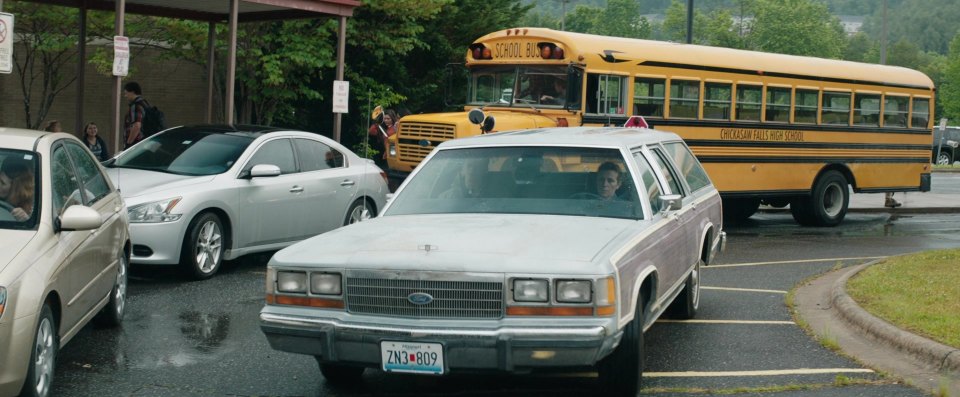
[0,128,130,396]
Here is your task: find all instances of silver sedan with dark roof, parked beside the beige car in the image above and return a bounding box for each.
[106,125,388,279]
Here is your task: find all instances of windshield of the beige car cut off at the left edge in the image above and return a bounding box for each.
[0,149,42,229]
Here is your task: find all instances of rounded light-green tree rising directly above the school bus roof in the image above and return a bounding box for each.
[750,0,844,58]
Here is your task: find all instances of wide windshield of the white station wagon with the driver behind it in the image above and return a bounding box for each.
[384,147,643,219]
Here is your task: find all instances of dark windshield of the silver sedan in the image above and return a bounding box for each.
[110,128,254,175]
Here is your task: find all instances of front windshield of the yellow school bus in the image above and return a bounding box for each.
[469,65,567,107]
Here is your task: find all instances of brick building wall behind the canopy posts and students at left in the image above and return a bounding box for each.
[0,46,212,152]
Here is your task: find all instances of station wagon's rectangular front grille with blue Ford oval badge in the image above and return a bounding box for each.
[346,277,503,319]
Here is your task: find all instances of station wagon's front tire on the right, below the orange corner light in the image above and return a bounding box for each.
[597,299,644,397]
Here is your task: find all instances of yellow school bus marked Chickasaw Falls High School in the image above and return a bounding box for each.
[387,28,935,226]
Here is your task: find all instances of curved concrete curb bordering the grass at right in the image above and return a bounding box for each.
[830,259,960,373]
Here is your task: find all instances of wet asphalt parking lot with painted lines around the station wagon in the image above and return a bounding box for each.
[45,209,960,396]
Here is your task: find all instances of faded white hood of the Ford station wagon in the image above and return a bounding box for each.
[274,214,639,271]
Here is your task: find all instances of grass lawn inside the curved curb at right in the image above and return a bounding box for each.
[847,249,960,348]
